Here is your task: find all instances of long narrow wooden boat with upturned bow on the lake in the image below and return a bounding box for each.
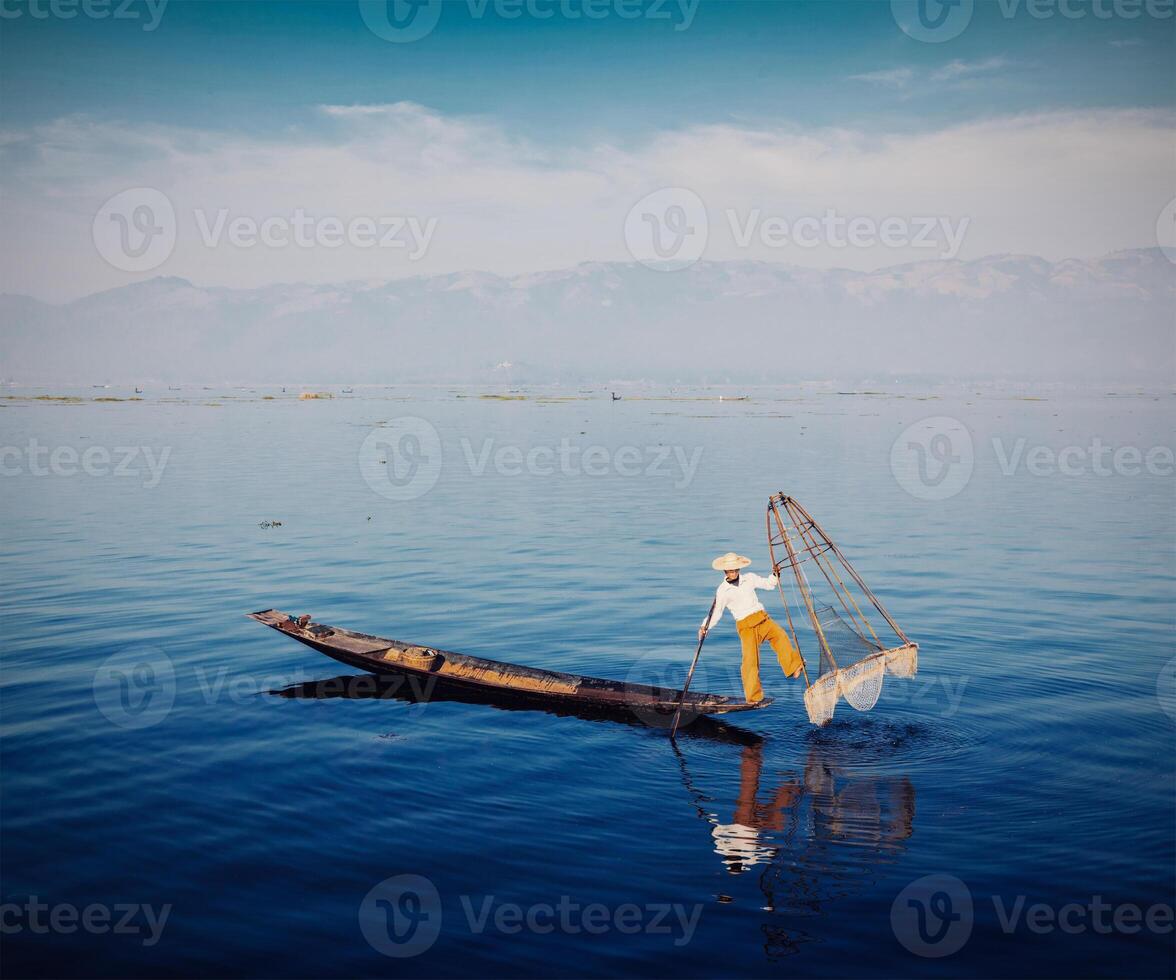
[248,609,771,715]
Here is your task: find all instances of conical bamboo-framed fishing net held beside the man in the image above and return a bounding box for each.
[768,493,918,725]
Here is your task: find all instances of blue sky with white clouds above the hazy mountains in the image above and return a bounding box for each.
[0,0,1176,302]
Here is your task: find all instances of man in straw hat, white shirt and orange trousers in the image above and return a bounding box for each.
[699,552,801,705]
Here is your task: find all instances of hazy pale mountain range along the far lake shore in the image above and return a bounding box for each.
[0,248,1176,384]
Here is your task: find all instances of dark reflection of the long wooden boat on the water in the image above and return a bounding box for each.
[269,674,763,745]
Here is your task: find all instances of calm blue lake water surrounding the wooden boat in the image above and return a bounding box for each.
[0,388,1176,976]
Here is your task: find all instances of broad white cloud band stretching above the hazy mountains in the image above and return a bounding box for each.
[0,102,1174,299]
